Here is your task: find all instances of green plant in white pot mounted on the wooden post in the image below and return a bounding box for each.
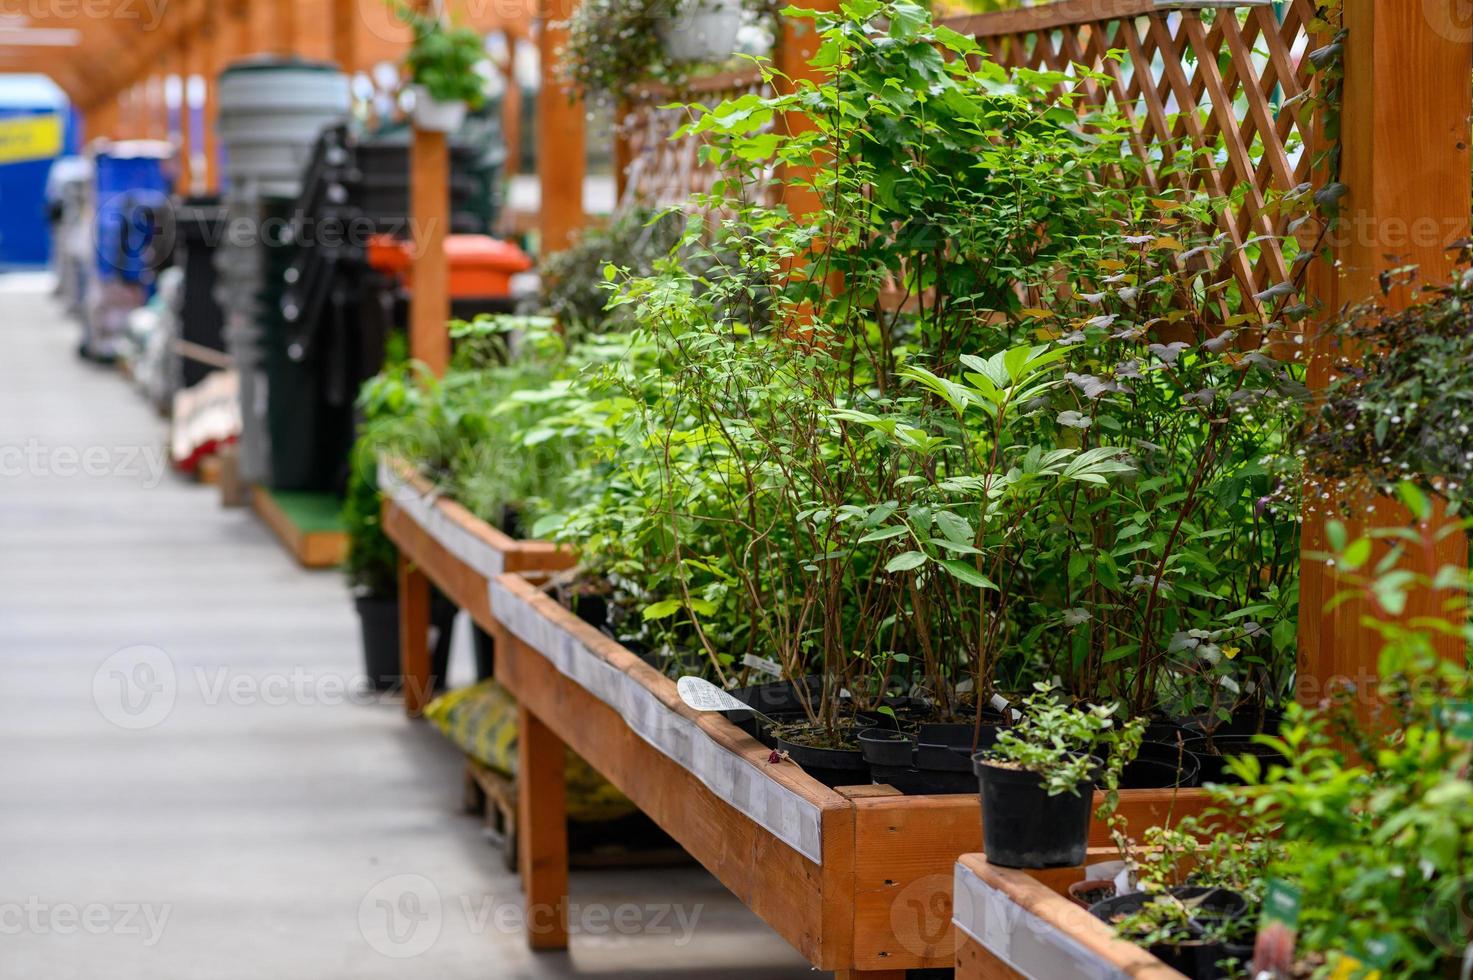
[399,6,486,133]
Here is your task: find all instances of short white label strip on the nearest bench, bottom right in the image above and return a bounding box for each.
[952,864,1128,980]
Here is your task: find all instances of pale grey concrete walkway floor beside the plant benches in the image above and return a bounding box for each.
[0,277,818,980]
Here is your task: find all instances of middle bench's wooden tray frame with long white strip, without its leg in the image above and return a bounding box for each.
[492,575,1206,977]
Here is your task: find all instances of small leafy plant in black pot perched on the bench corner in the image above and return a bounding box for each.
[972,684,1145,868]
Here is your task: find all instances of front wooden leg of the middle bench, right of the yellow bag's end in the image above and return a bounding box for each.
[517,704,567,949]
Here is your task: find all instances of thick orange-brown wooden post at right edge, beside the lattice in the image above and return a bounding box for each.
[1298,0,1473,712]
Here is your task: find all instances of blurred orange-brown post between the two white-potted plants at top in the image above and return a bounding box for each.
[538,0,588,255]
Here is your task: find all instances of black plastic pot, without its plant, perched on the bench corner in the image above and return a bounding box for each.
[972,752,1094,868]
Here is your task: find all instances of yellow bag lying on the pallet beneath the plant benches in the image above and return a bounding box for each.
[424,681,635,822]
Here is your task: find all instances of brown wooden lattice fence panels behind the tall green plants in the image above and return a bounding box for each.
[603,0,1317,309]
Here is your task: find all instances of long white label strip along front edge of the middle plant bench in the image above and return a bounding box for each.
[491,579,823,864]
